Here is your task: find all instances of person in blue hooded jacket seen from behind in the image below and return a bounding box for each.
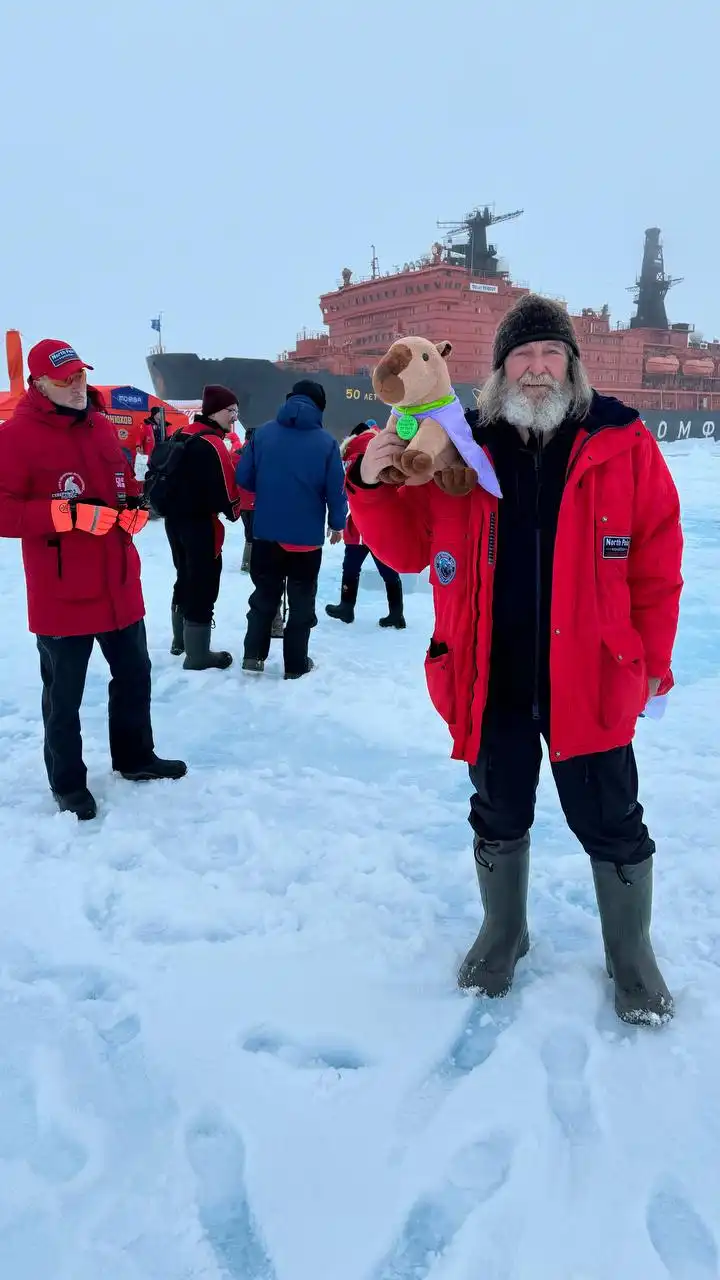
[236,379,347,680]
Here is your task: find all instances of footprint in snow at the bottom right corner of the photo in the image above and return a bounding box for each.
[646,1187,720,1280]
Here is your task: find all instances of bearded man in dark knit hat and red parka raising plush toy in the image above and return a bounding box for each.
[347,294,683,1023]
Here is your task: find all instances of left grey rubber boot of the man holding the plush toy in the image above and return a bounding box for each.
[457,835,530,997]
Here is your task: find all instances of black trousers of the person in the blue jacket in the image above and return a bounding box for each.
[245,539,323,676]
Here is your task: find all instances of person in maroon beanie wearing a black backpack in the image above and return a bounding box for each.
[154,385,241,671]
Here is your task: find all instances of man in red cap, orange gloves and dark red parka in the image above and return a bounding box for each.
[0,338,187,820]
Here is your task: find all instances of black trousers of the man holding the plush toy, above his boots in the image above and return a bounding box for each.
[470,710,655,864]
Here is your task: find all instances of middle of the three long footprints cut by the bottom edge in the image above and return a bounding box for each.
[373,1133,512,1280]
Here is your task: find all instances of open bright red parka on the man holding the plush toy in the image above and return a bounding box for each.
[347,419,683,764]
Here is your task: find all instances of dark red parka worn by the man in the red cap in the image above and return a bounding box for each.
[0,387,145,636]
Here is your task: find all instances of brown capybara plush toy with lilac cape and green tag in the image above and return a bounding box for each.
[373,338,500,497]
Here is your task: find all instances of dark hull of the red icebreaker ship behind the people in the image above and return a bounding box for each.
[147,352,720,444]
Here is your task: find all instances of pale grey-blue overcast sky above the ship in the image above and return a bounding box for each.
[0,0,720,387]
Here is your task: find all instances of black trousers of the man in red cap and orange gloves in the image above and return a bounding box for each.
[37,622,154,795]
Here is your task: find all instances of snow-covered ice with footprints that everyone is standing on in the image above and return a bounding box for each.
[0,443,720,1280]
